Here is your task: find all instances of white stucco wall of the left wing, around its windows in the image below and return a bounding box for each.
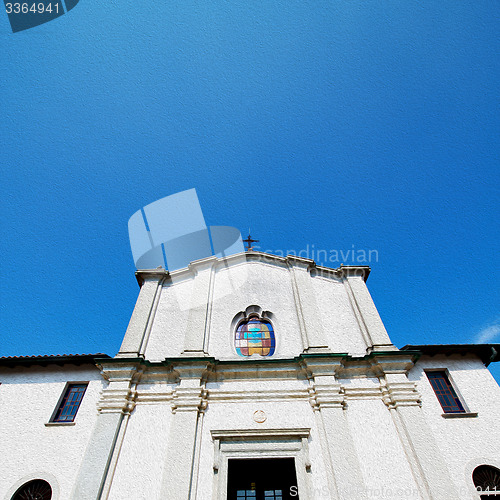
[0,365,104,500]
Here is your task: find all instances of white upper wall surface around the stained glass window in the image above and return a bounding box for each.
[145,259,367,361]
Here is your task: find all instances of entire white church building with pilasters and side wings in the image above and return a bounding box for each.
[0,251,500,500]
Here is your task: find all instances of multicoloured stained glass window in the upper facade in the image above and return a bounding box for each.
[235,318,275,356]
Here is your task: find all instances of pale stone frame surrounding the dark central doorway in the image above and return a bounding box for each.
[211,428,311,500]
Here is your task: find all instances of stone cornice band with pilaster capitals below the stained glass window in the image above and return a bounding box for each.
[93,351,426,414]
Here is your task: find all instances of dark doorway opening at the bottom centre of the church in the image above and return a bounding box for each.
[227,458,299,500]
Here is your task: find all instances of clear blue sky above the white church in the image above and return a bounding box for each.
[0,0,500,379]
